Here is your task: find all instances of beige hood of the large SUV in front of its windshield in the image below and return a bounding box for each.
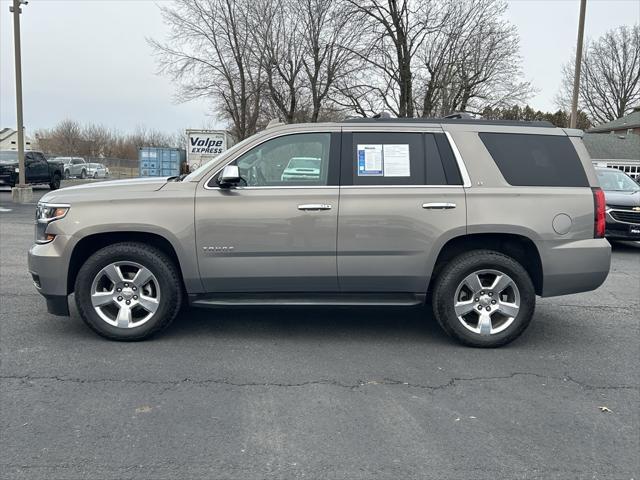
[40,177,170,203]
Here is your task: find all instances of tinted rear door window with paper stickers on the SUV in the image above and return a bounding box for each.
[348,132,462,185]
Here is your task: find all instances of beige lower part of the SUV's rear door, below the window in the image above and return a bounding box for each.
[338,186,466,293]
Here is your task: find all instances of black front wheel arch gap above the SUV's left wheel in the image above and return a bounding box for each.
[67,231,185,294]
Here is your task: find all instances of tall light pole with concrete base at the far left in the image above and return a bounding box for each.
[9,0,33,203]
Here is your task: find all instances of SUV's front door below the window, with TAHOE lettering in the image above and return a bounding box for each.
[195,186,338,292]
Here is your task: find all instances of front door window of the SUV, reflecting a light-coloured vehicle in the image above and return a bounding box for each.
[234,133,331,187]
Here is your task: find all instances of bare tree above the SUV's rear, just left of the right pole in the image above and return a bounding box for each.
[416,0,533,116]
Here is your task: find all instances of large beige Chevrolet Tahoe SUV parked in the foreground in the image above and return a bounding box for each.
[29,119,611,347]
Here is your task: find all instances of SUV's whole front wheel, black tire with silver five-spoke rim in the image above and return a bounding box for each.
[75,243,182,341]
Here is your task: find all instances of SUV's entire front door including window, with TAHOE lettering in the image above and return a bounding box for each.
[195,131,340,292]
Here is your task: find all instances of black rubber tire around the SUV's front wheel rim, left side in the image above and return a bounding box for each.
[75,242,183,341]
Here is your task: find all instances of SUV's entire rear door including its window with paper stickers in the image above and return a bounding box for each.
[337,128,466,293]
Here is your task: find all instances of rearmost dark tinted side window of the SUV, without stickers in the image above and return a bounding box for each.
[479,133,589,187]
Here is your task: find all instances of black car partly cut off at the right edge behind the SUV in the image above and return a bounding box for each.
[596,168,640,240]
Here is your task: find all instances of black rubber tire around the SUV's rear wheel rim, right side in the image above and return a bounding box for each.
[432,250,536,348]
